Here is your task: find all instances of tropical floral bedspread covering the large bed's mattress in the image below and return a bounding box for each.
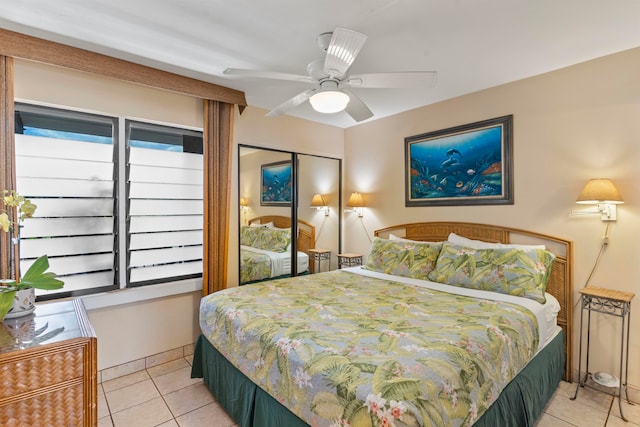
[200,270,538,427]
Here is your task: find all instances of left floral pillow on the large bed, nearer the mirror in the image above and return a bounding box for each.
[365,237,442,279]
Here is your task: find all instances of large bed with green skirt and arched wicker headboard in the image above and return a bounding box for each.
[192,222,572,427]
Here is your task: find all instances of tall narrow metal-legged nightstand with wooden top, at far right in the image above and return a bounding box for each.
[571,286,635,421]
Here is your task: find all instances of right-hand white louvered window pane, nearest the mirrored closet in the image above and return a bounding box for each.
[127,122,204,286]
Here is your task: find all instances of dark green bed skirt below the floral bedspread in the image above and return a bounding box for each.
[191,332,565,427]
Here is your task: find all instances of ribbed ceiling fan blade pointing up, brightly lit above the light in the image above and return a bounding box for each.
[324,27,367,78]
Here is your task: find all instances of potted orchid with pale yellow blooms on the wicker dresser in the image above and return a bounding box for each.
[0,190,64,320]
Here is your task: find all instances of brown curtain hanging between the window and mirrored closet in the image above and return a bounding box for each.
[202,99,233,295]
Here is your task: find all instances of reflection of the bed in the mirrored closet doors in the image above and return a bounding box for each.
[240,215,315,284]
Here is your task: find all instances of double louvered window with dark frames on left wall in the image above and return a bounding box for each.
[15,104,203,299]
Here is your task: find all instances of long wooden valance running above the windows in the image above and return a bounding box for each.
[0,29,247,106]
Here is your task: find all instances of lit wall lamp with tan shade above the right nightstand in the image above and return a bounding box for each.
[571,178,624,221]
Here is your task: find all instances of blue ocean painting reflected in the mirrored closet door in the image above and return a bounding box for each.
[260,160,293,206]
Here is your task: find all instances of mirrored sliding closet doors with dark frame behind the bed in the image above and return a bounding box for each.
[238,145,341,284]
